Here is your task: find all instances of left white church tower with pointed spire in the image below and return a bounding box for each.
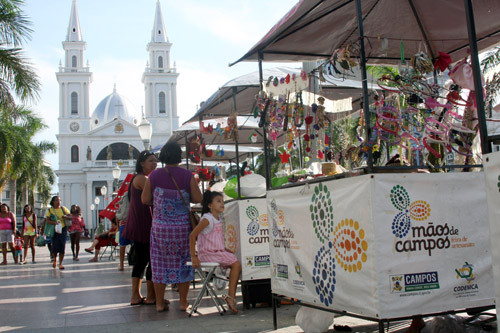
[56,0,92,167]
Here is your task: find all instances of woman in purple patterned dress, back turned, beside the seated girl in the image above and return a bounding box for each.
[142,142,202,312]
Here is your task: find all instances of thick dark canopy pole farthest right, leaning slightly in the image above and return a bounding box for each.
[464,0,491,154]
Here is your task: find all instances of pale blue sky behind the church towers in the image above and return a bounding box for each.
[23,0,297,175]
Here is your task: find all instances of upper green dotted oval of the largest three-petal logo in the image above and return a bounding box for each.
[309,183,333,243]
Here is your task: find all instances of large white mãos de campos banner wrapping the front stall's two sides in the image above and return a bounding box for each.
[267,173,493,319]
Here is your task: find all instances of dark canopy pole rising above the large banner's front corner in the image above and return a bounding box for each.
[356,0,373,173]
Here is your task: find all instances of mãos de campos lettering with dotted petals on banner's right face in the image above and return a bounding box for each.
[390,185,458,256]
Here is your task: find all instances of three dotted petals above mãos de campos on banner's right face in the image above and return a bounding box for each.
[391,185,431,238]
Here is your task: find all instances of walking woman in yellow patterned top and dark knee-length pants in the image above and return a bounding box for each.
[45,195,72,269]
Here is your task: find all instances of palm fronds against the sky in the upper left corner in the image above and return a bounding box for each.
[0,0,40,112]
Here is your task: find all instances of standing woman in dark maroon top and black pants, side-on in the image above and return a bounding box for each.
[123,150,158,305]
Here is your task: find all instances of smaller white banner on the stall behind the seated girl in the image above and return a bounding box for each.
[224,198,270,281]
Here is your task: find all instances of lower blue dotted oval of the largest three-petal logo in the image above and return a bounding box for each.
[312,243,336,306]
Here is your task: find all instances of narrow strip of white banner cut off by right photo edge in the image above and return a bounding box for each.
[483,152,500,316]
